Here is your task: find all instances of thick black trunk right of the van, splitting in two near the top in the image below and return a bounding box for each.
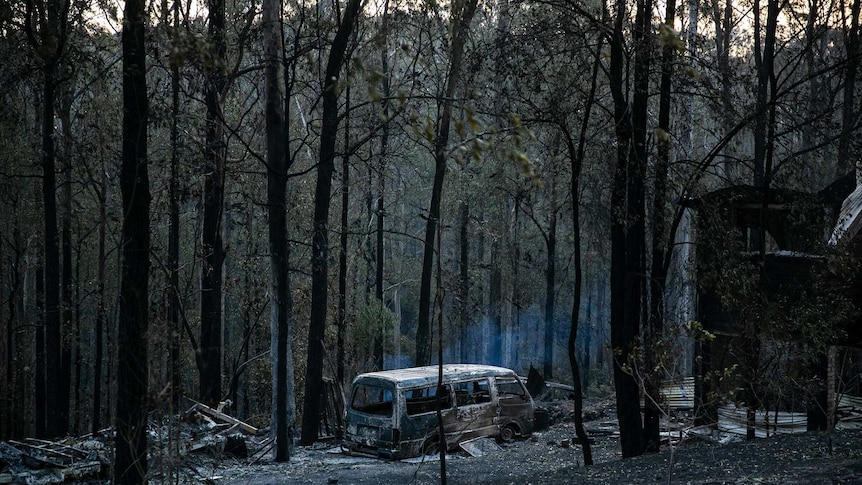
[609,0,652,458]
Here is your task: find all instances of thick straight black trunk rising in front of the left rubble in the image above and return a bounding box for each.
[114,0,150,476]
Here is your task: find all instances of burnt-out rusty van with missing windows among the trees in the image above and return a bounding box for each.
[344,364,535,459]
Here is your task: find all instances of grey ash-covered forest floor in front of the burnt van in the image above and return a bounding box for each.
[177,401,862,485]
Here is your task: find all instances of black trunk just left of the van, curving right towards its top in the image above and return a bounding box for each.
[300,0,361,445]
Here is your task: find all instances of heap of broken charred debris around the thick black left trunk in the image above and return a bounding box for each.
[0,400,272,485]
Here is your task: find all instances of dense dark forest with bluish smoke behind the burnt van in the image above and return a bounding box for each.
[0,0,862,476]
